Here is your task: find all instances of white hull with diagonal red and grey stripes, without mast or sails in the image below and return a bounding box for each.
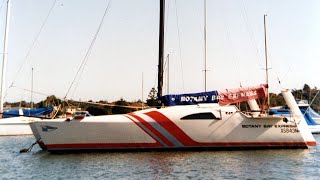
[31,106,316,152]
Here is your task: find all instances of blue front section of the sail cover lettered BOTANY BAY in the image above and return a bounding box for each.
[161,91,218,106]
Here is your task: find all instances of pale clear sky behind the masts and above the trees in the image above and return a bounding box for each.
[0,0,320,102]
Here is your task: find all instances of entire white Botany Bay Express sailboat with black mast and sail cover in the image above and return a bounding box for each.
[30,0,316,152]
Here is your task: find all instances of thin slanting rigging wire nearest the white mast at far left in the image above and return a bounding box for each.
[4,0,57,97]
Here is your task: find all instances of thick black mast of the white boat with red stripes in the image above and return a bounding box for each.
[157,0,165,100]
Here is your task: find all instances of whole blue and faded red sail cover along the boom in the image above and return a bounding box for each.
[161,84,267,106]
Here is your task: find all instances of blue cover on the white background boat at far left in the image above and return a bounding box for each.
[2,106,53,118]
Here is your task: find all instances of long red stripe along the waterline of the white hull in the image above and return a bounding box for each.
[46,142,306,150]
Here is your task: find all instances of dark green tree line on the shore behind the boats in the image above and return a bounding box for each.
[5,84,320,115]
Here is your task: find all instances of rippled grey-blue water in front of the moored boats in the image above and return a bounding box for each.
[0,135,320,179]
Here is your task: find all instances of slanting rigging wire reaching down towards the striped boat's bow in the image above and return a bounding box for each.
[64,0,112,99]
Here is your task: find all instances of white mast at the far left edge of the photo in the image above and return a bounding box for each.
[0,0,10,113]
